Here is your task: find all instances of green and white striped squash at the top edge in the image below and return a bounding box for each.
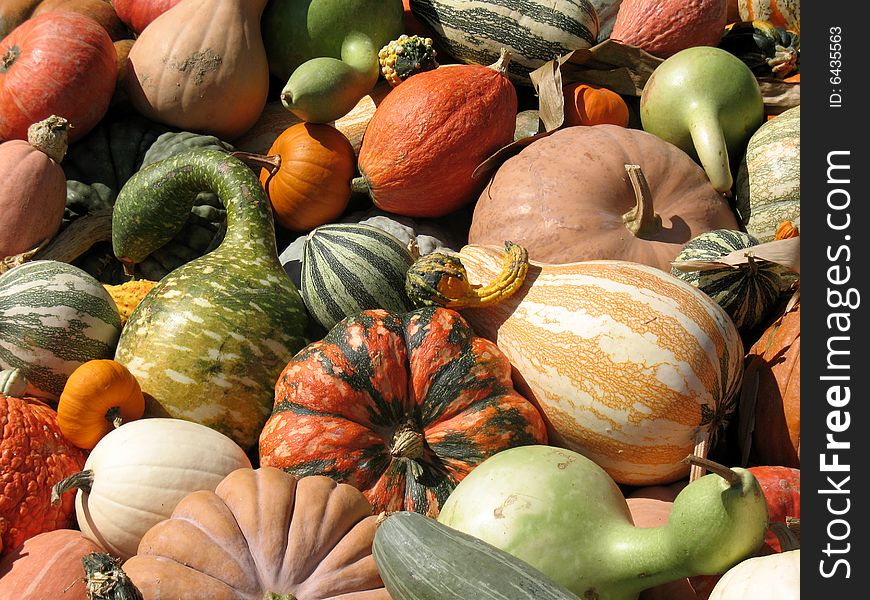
[410,0,599,85]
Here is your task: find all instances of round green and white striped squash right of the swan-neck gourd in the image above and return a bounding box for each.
[300,223,414,331]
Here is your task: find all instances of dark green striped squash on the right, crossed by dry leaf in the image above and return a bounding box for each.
[671,229,783,333]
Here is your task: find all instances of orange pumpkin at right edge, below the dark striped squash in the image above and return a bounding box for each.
[744,302,801,468]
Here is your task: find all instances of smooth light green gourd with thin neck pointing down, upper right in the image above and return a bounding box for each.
[640,46,764,194]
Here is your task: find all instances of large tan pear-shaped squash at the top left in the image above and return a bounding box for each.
[125,0,269,140]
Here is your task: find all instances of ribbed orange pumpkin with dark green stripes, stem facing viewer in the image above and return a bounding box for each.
[260,307,547,517]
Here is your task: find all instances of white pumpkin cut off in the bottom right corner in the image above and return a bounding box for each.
[709,549,801,600]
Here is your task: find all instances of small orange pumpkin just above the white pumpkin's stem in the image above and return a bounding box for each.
[57,359,145,450]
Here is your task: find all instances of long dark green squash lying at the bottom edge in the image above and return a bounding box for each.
[372,511,579,600]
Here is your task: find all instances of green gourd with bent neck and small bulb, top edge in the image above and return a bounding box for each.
[261,0,404,123]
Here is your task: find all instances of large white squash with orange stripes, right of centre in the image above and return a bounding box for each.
[459,245,744,485]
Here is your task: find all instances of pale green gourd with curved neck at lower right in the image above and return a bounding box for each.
[438,445,768,600]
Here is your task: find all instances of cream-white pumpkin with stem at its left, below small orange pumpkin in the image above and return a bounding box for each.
[54,418,251,560]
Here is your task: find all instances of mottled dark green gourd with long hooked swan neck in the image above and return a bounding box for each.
[112,149,308,449]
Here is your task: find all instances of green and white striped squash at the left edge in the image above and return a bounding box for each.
[0,260,121,403]
